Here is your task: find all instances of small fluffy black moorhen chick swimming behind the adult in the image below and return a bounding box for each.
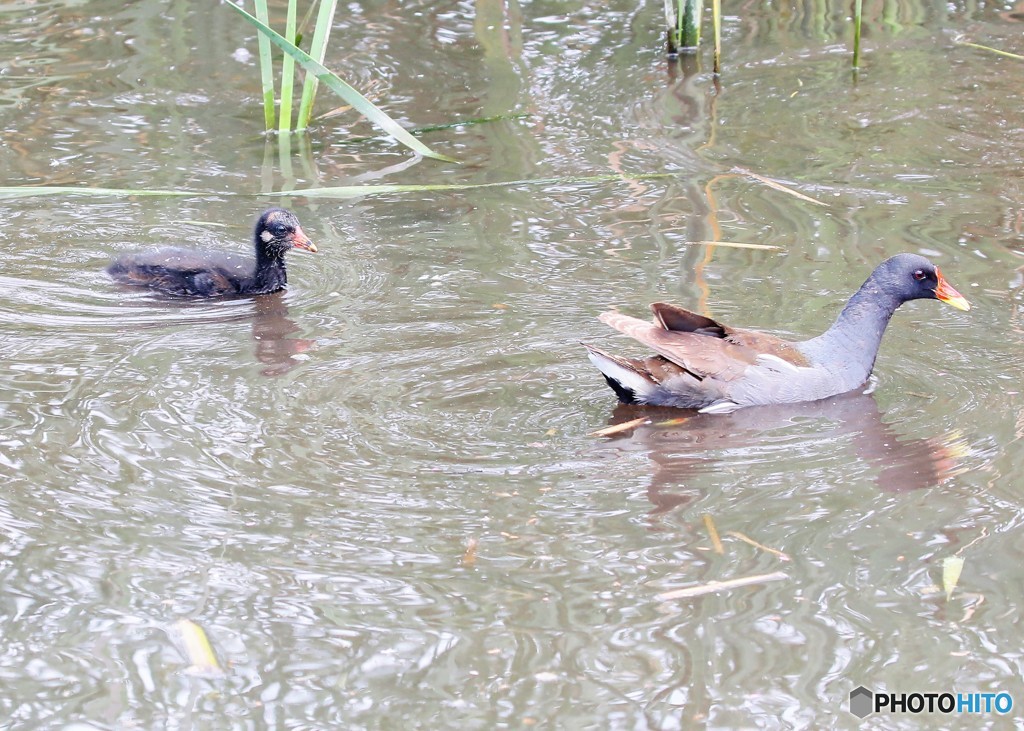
[106,208,316,297]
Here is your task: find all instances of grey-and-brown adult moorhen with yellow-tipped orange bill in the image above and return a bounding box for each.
[584,254,971,414]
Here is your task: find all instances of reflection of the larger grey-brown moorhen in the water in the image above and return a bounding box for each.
[602,393,966,515]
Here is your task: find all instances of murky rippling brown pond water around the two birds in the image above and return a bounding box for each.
[0,0,1024,730]
